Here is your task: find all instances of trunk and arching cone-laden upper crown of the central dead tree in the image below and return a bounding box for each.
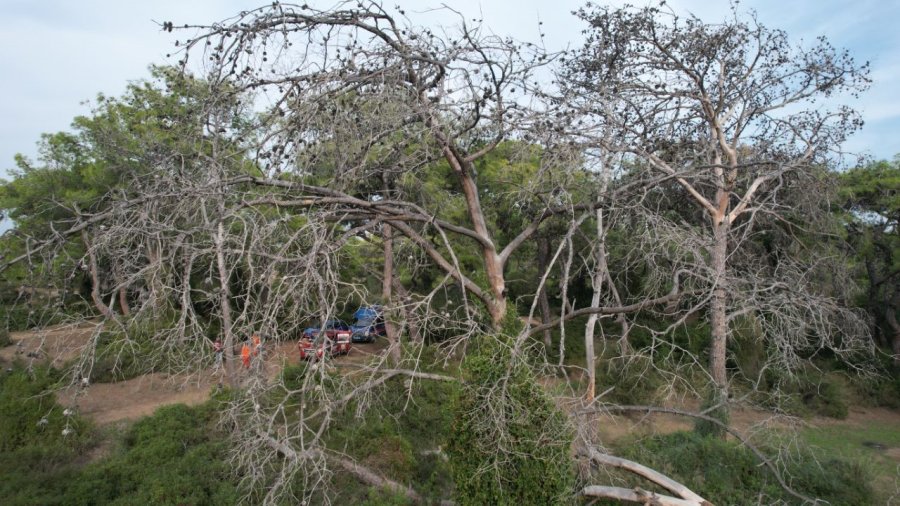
[169,3,572,332]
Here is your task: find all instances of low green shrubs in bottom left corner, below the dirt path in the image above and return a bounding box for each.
[0,366,239,506]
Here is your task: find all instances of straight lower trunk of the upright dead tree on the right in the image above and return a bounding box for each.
[709,221,728,399]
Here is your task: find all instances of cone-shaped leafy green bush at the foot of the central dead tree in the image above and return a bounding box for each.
[447,336,574,505]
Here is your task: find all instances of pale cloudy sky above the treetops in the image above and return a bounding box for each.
[0,0,900,175]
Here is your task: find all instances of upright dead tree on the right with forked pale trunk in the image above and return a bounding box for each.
[561,3,868,406]
